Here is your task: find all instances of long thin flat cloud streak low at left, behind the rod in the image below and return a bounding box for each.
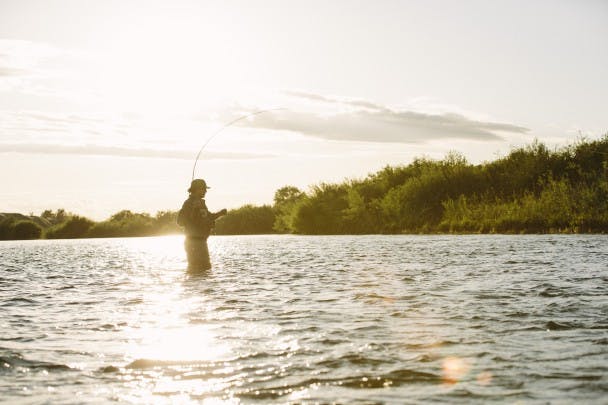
[0,143,273,162]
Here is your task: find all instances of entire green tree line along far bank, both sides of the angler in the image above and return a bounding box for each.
[0,134,608,239]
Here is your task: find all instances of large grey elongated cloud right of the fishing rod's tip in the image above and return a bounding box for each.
[233,91,528,143]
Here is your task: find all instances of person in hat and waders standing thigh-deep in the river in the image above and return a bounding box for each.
[177,179,227,271]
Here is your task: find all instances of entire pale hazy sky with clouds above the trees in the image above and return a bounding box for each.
[0,0,608,219]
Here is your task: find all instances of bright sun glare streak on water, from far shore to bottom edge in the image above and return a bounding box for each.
[101,235,241,403]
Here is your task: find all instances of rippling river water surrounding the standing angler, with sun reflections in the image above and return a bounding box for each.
[0,235,608,404]
